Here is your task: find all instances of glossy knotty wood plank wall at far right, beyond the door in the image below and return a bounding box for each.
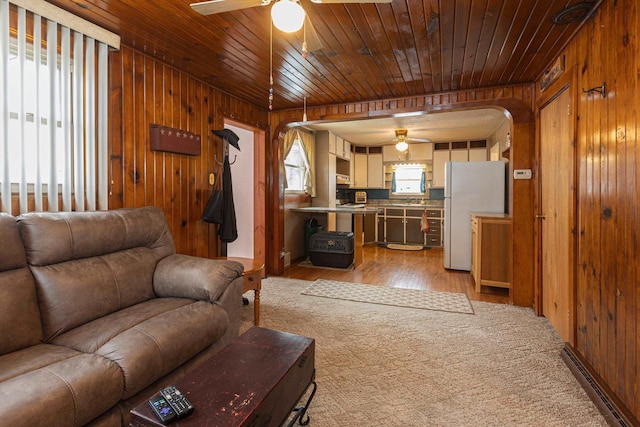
[537,0,640,422]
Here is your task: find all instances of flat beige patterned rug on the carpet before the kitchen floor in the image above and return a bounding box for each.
[302,279,473,314]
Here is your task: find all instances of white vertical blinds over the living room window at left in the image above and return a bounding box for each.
[0,0,120,214]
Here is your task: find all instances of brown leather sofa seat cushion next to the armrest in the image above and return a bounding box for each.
[53,298,229,399]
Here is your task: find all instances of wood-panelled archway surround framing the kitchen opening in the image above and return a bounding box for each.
[268,84,535,307]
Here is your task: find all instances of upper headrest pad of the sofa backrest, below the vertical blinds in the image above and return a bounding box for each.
[18,206,175,266]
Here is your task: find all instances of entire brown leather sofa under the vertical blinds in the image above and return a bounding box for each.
[0,207,242,427]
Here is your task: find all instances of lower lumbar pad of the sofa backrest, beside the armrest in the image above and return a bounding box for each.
[31,247,158,341]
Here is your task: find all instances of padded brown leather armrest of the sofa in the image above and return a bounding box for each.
[153,254,243,301]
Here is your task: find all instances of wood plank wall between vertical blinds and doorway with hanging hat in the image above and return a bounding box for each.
[109,46,268,257]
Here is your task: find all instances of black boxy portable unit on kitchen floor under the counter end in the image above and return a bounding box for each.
[309,231,353,268]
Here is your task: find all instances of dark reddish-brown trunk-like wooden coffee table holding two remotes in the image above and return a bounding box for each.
[130,326,316,427]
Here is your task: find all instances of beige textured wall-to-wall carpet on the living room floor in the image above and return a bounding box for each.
[242,278,606,427]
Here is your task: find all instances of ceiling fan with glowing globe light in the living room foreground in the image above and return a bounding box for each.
[191,0,392,51]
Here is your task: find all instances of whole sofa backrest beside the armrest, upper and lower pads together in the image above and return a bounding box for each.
[18,207,175,341]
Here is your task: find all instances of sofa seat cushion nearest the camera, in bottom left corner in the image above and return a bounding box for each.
[0,350,123,427]
